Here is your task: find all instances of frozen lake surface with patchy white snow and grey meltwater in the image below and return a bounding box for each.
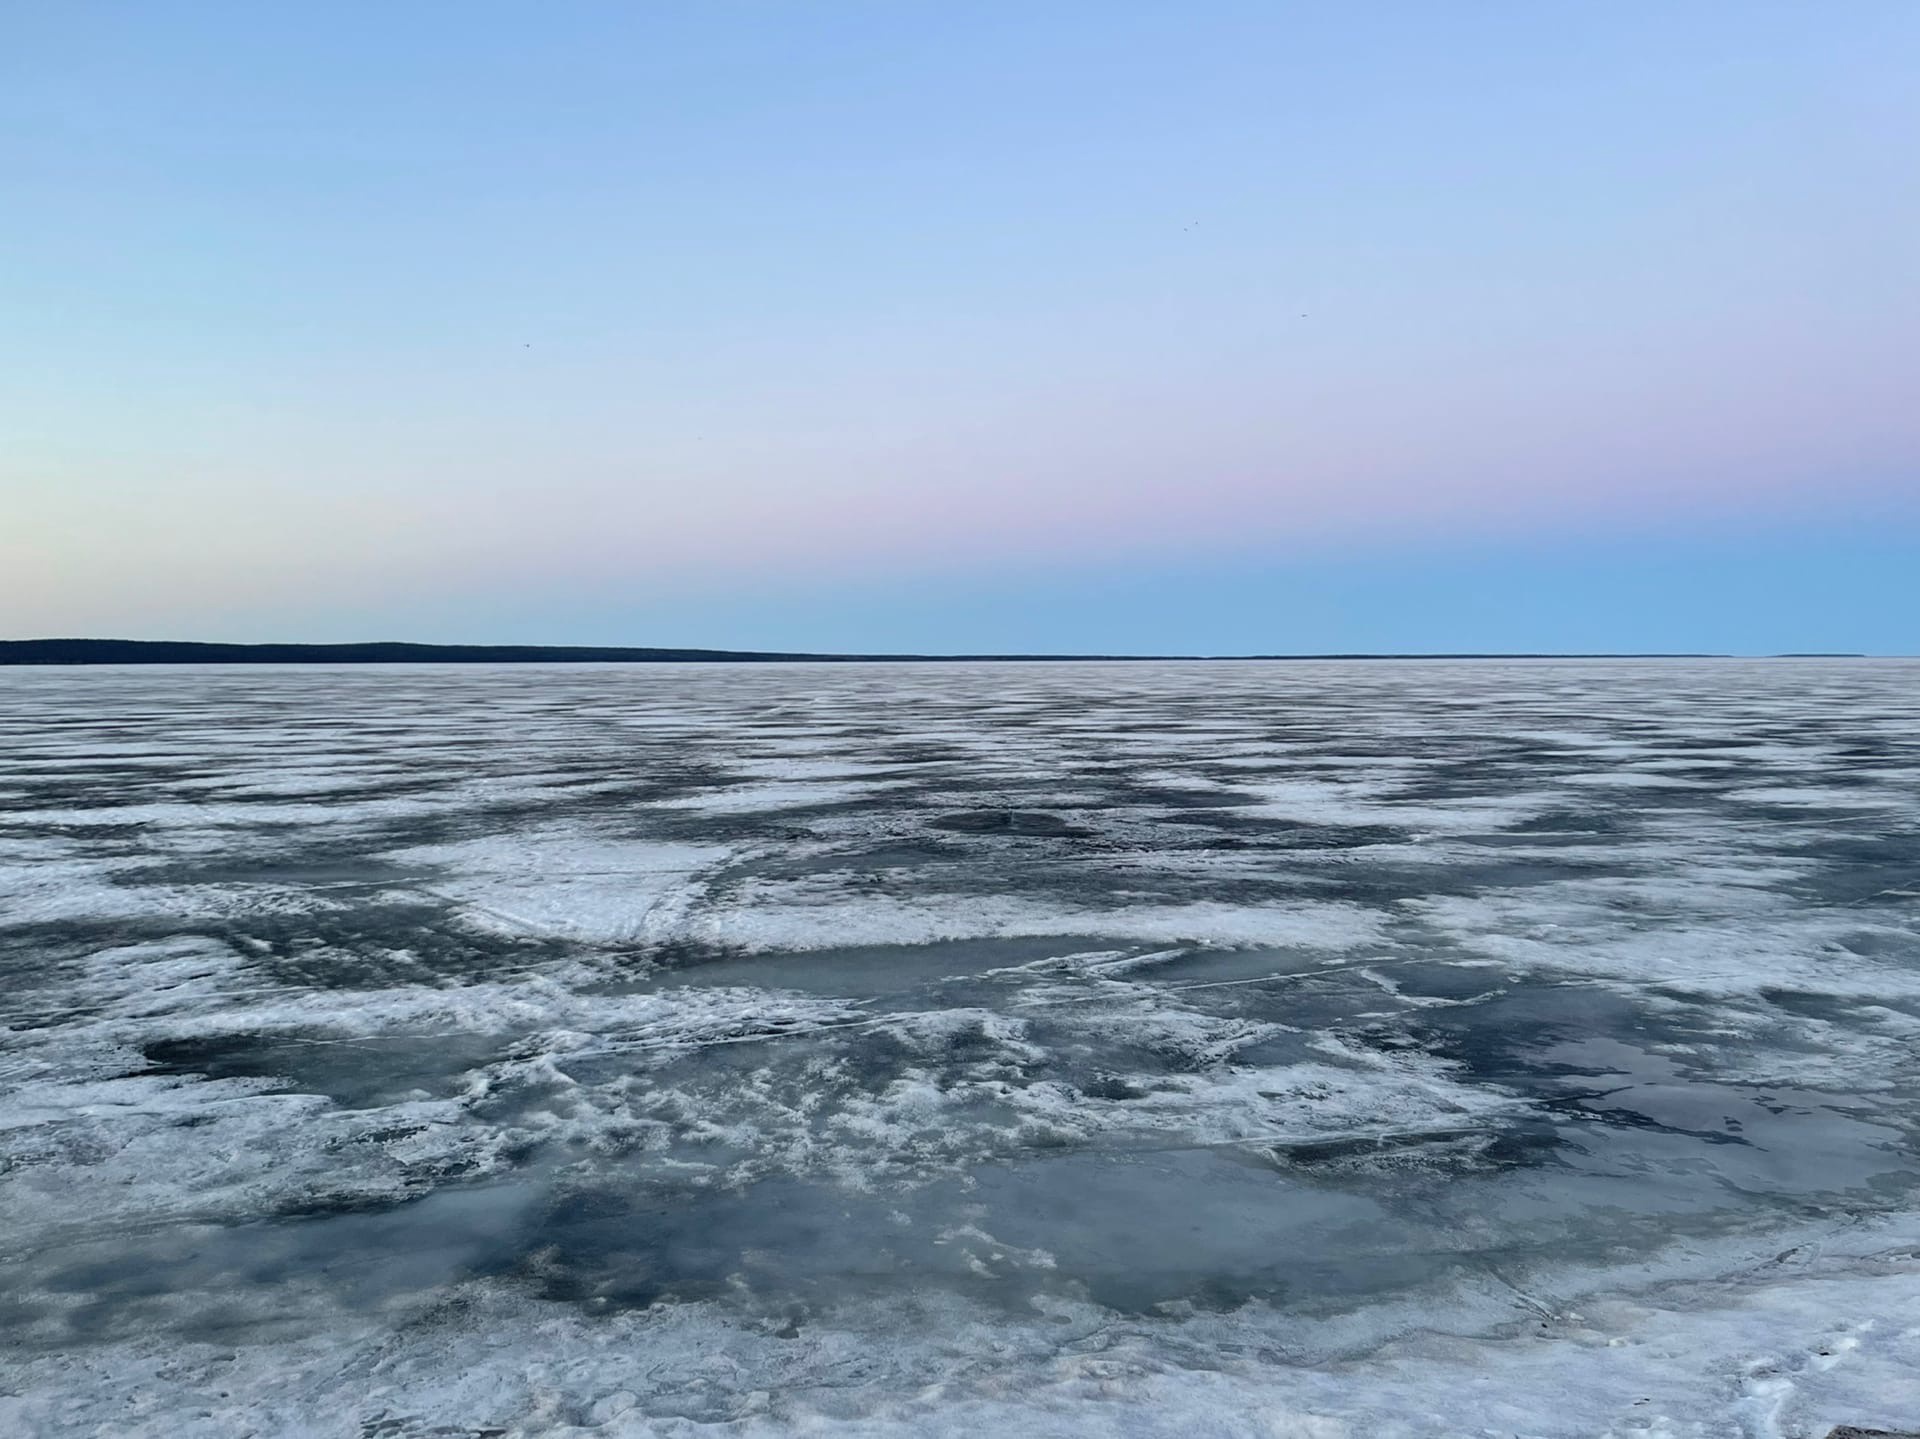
[0,661,1920,1439]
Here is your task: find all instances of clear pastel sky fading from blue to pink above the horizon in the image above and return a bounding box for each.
[0,0,1920,653]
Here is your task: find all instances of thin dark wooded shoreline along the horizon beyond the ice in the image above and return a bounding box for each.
[0,640,1827,665]
